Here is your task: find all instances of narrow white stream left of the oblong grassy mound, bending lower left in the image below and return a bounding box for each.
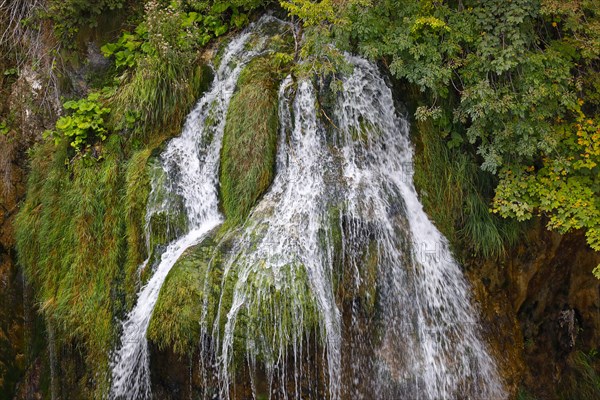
[110,16,282,399]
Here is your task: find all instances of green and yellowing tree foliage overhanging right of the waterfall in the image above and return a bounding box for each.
[348,0,600,274]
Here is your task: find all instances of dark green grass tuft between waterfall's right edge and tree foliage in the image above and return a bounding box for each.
[414,121,521,259]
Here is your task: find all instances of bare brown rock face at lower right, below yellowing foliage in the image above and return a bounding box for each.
[469,221,600,399]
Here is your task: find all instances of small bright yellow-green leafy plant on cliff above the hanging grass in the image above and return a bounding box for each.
[44,93,110,153]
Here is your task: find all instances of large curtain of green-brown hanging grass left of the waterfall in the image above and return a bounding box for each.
[16,135,164,397]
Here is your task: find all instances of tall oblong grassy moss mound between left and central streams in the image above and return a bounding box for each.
[220,57,278,224]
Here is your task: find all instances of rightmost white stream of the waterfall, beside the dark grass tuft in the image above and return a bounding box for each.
[334,57,505,399]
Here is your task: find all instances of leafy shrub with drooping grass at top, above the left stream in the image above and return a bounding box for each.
[103,2,216,139]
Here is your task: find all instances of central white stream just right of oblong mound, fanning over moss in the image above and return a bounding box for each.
[203,79,340,398]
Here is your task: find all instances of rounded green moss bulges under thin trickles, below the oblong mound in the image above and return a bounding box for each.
[147,227,320,370]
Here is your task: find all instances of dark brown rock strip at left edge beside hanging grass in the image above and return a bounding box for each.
[0,58,52,399]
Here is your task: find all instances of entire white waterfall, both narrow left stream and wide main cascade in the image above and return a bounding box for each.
[111,17,506,400]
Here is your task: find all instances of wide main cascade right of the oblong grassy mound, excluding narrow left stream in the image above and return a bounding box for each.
[201,57,506,400]
